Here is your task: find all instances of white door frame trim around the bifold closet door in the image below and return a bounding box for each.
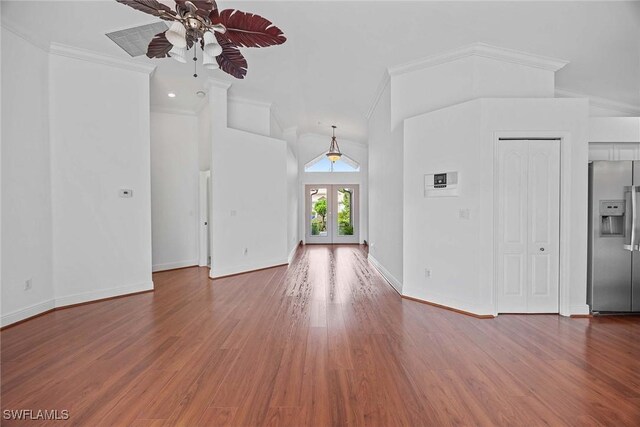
[492,131,571,316]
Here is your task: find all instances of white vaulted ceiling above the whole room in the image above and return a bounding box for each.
[2,0,640,141]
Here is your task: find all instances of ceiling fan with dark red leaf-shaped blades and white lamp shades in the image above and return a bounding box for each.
[116,0,287,79]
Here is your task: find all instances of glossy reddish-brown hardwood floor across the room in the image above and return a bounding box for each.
[0,246,640,426]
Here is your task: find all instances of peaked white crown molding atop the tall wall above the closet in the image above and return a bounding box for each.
[389,43,569,77]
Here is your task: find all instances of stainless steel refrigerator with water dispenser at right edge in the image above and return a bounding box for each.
[587,161,640,313]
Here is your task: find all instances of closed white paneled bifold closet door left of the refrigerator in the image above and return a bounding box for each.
[497,140,560,313]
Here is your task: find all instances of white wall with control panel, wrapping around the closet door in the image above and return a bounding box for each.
[403,99,588,315]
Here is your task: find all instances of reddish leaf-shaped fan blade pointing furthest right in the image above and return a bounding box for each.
[213,9,287,47]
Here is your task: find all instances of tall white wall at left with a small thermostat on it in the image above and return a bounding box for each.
[50,48,153,305]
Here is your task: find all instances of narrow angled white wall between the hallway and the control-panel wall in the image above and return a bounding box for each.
[368,84,403,292]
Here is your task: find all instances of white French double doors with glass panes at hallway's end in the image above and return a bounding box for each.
[304,184,360,244]
